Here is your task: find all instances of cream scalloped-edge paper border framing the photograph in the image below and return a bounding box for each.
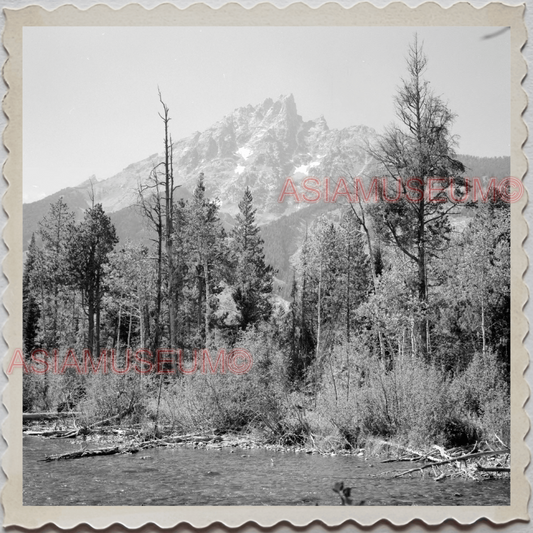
[2,2,530,529]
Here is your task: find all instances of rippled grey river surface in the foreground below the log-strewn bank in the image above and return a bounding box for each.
[23,437,510,506]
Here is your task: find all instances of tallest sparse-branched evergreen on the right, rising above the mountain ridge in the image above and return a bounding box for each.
[371,37,464,356]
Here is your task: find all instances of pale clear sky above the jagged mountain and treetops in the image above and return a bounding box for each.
[23,27,510,202]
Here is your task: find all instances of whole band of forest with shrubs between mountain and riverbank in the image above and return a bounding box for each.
[23,41,510,449]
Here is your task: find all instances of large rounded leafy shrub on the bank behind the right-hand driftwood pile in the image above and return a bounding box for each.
[318,342,484,448]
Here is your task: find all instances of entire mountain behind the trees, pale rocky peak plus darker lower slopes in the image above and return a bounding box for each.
[23,95,510,297]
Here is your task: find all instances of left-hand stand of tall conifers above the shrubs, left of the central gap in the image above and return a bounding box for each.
[23,175,273,409]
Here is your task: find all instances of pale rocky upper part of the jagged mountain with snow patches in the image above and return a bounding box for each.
[24,95,375,242]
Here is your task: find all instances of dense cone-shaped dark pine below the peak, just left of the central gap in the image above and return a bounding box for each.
[231,187,274,330]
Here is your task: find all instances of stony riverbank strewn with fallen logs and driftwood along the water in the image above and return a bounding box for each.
[23,419,510,482]
